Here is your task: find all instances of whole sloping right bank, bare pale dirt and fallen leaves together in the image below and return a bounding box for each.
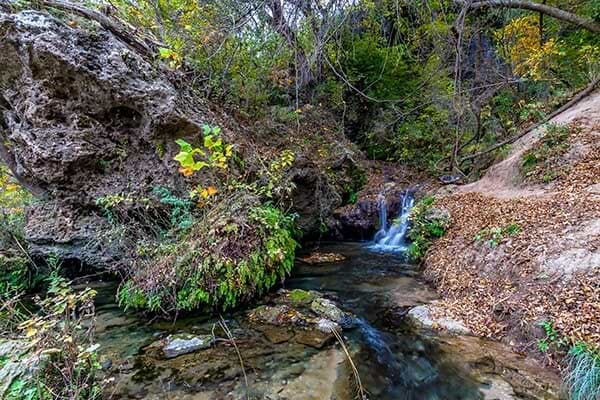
[425,91,600,357]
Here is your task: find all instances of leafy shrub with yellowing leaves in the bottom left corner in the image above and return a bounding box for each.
[0,275,101,400]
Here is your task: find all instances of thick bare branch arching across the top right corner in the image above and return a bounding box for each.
[454,0,600,33]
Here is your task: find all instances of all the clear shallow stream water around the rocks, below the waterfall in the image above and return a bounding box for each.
[98,239,549,400]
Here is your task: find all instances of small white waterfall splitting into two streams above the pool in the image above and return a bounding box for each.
[373,191,415,251]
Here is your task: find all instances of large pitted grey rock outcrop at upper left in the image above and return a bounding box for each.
[0,11,202,265]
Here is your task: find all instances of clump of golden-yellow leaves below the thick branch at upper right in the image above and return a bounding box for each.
[494,16,560,80]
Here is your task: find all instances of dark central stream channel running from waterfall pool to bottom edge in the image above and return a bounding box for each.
[286,243,483,400]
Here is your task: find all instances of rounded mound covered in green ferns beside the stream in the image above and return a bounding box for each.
[118,194,296,314]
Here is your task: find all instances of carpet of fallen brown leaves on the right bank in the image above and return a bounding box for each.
[425,126,600,347]
